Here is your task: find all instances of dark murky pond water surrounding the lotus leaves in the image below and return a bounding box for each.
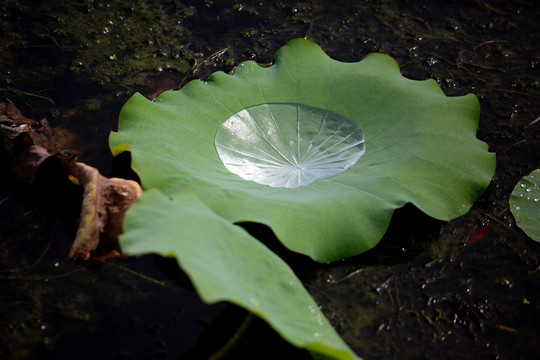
[0,0,540,360]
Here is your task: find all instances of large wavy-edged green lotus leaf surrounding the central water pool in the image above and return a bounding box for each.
[110,39,495,262]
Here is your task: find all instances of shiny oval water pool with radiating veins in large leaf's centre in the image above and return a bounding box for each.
[215,103,366,188]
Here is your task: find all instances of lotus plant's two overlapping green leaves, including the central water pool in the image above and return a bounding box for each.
[110,39,495,359]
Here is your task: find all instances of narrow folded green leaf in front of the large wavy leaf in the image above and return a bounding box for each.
[120,190,358,359]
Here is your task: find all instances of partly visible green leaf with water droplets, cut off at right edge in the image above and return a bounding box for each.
[510,169,540,242]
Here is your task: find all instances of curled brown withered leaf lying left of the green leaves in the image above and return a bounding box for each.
[0,100,142,261]
